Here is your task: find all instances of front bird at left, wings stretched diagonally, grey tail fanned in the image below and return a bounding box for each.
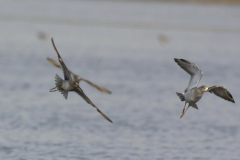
[50,38,112,123]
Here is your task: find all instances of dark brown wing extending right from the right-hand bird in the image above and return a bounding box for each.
[208,86,235,103]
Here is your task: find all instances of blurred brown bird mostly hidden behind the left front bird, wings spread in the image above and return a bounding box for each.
[47,58,111,94]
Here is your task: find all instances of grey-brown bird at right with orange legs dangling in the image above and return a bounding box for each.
[174,58,235,118]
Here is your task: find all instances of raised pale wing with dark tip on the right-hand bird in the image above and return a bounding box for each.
[174,58,203,93]
